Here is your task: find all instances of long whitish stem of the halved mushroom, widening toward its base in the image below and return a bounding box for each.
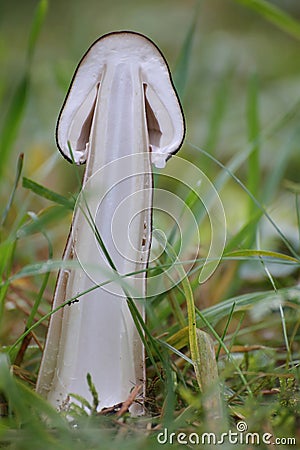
[38,65,152,407]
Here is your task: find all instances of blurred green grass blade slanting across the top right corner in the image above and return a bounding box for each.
[235,0,300,39]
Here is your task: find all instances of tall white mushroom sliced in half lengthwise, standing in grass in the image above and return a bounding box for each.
[37,31,185,412]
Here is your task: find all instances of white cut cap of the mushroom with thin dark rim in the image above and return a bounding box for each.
[56,31,185,167]
